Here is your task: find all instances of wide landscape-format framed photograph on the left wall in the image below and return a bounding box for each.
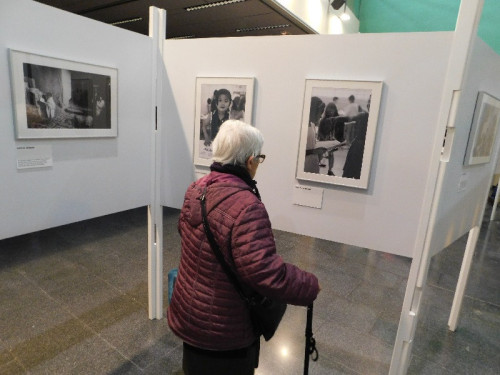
[9,50,118,139]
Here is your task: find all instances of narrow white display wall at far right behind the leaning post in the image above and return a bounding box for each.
[431,38,500,254]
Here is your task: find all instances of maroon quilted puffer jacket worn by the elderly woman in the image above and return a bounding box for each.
[167,171,319,350]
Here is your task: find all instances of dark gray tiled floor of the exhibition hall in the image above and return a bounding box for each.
[0,208,500,375]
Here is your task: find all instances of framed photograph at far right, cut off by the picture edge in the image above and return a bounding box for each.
[464,92,500,165]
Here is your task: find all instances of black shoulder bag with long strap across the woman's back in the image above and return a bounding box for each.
[200,189,287,341]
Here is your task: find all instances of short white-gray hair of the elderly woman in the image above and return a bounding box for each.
[212,120,264,166]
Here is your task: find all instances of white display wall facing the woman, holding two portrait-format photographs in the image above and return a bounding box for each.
[162,32,452,257]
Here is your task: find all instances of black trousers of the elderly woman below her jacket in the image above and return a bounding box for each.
[182,340,260,375]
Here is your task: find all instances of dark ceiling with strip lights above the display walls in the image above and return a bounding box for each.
[37,0,315,39]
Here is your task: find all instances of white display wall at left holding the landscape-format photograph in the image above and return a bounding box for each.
[0,0,153,239]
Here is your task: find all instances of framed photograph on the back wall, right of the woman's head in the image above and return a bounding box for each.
[296,79,383,189]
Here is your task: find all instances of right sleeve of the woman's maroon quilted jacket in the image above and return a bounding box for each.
[231,195,319,306]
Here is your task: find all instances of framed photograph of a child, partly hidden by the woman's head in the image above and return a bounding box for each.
[193,77,254,166]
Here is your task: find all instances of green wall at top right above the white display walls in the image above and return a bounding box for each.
[354,0,500,54]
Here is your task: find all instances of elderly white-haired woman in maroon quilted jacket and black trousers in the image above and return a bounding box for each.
[168,120,320,375]
